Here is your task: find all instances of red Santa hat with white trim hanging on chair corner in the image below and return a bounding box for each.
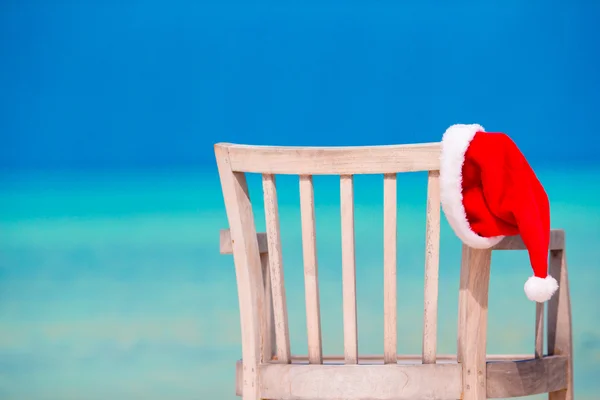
[440,124,558,302]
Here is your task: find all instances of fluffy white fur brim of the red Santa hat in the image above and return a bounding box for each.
[440,124,504,249]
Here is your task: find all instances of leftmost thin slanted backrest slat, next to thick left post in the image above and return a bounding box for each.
[259,175,290,363]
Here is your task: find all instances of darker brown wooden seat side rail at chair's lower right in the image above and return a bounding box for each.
[488,356,568,399]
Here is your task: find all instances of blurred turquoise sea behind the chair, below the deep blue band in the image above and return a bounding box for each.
[0,167,600,400]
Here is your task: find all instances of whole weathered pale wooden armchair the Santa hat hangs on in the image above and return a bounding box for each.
[215,143,573,400]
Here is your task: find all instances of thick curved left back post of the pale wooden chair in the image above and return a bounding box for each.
[215,146,265,400]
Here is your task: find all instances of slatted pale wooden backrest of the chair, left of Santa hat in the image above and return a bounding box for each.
[215,143,440,372]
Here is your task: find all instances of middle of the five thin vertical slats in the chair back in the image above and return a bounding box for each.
[340,175,358,364]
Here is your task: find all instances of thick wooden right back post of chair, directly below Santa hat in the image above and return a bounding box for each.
[460,248,492,400]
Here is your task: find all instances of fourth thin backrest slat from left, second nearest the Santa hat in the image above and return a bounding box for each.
[383,174,398,364]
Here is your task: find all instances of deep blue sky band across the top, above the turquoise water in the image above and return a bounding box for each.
[0,0,600,170]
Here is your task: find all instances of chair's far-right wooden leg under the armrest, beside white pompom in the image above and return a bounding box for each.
[548,250,574,400]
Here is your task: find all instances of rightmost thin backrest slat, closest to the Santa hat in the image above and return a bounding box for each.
[423,171,440,364]
